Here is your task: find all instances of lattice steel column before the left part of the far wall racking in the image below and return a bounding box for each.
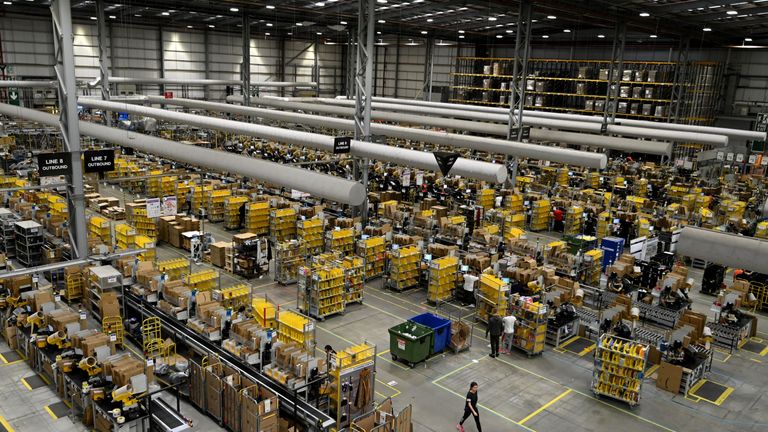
[507,0,532,187]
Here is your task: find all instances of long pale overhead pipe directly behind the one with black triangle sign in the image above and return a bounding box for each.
[147,96,608,169]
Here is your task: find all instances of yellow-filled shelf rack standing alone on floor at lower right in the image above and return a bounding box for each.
[592,334,648,406]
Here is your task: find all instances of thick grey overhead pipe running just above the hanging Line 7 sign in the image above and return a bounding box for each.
[0,104,366,206]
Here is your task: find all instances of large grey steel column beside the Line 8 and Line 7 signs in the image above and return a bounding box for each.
[51,0,88,258]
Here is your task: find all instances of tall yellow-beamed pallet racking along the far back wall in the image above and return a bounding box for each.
[450,57,723,124]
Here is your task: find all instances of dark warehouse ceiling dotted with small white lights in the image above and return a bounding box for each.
[0,0,768,46]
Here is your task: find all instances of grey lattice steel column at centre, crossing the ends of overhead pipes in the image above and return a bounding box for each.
[355,0,376,223]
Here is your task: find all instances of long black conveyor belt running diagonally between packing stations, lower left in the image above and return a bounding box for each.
[125,291,336,432]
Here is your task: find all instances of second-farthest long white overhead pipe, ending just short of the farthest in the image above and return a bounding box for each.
[308,98,728,147]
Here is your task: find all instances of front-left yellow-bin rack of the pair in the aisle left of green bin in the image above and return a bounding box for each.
[298,262,345,319]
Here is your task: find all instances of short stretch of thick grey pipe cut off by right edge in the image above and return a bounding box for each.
[677,226,768,274]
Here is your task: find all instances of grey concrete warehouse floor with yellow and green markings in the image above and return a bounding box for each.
[0,184,768,432]
